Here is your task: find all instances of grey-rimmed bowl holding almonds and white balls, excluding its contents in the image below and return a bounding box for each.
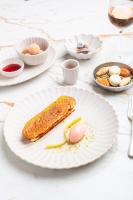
[93,62,133,92]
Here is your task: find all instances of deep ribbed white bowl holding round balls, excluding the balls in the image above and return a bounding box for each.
[16,37,49,65]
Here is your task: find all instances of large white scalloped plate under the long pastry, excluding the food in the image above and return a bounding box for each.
[4,87,118,169]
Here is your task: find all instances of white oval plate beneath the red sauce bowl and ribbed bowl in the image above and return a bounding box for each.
[0,47,56,86]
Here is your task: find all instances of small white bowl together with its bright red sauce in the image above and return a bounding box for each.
[0,58,24,78]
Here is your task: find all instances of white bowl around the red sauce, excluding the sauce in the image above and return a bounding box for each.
[0,57,24,78]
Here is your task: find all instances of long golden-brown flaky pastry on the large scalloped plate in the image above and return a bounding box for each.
[22,96,76,141]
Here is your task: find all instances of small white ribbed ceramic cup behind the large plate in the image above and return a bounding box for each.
[62,59,79,85]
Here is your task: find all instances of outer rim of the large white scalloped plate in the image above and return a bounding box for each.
[3,86,119,170]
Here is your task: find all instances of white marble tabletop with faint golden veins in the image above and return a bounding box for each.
[0,0,133,200]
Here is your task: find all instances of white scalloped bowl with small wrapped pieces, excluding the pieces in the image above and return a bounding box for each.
[65,34,102,59]
